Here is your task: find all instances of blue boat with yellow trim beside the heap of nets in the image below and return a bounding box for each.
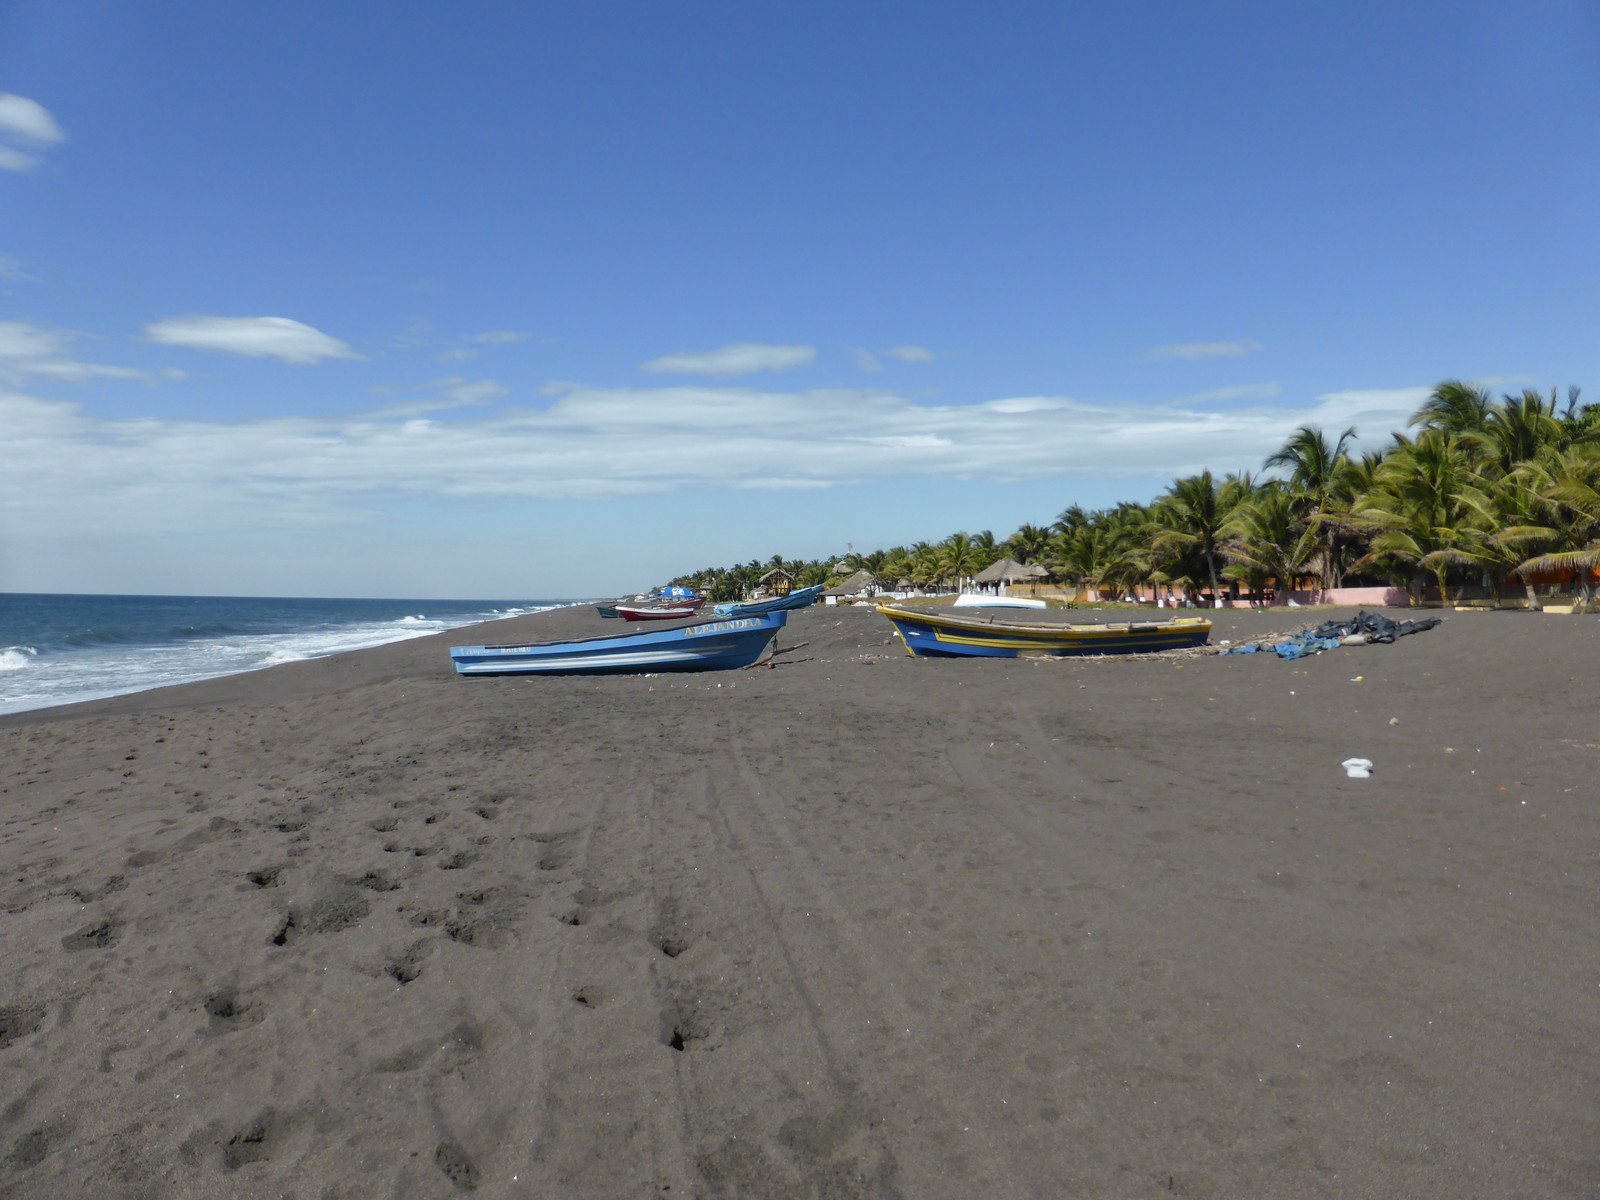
[878,605,1211,658]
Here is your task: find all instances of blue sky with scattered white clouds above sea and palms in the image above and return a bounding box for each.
[0,0,1600,598]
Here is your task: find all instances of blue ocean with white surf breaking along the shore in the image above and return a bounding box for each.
[0,592,581,714]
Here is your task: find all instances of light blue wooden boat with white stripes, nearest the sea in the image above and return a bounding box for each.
[450,613,789,675]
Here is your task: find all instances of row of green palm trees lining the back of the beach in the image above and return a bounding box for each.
[672,379,1600,605]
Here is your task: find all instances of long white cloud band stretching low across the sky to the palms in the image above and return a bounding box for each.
[0,378,1429,538]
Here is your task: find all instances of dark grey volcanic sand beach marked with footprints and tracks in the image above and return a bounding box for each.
[0,608,1600,1200]
